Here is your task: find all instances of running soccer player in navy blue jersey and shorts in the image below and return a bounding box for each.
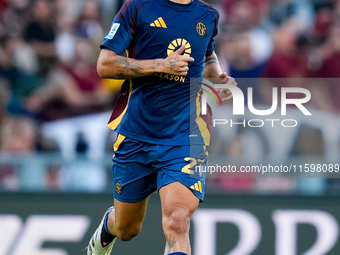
[87,0,235,255]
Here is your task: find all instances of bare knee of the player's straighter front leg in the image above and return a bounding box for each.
[162,207,192,234]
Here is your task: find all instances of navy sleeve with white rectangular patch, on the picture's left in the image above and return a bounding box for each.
[100,0,137,55]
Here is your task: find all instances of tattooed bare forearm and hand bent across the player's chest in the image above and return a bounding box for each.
[97,45,194,79]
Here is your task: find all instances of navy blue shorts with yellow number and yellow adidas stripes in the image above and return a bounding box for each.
[112,135,208,202]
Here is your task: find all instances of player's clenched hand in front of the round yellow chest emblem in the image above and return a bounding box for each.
[163,44,194,76]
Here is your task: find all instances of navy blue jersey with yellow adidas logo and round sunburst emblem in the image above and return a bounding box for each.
[101,0,219,145]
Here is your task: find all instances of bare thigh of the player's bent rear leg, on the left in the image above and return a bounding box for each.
[114,197,149,232]
